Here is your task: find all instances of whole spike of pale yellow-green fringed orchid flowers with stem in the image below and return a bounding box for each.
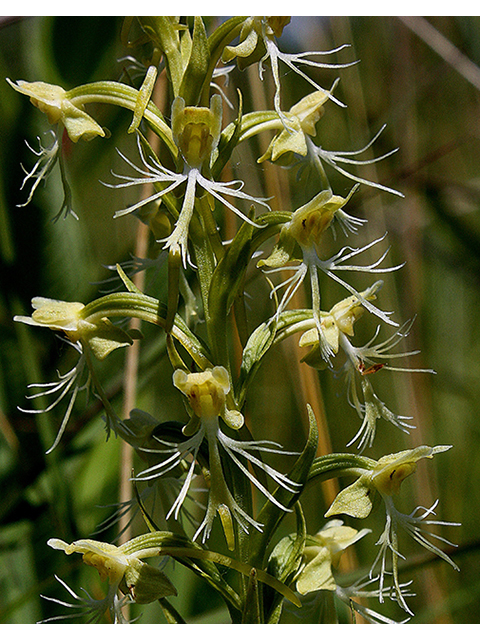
[8,16,457,623]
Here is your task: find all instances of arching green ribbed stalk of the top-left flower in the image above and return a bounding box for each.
[66,80,178,159]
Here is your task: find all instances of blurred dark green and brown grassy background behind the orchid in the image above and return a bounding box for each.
[0,17,480,623]
